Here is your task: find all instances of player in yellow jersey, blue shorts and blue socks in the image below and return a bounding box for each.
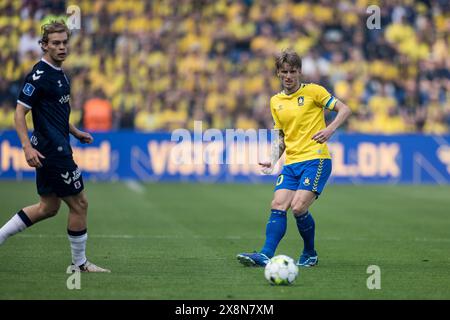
[237,50,351,267]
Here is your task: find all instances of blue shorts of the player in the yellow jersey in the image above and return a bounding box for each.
[275,159,331,195]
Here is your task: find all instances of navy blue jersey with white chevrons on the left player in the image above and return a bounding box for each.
[17,59,72,158]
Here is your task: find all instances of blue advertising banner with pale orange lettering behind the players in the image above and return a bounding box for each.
[0,130,450,184]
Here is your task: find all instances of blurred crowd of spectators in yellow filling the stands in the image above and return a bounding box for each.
[0,0,450,134]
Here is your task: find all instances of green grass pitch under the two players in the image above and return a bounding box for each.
[0,182,450,300]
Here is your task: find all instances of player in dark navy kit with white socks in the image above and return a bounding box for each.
[0,21,110,272]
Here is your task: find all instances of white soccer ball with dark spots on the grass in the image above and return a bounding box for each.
[264,255,298,285]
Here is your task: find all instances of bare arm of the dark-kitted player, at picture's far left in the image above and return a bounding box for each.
[14,104,45,168]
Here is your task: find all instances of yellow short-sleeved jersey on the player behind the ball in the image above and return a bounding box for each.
[270,83,337,164]
